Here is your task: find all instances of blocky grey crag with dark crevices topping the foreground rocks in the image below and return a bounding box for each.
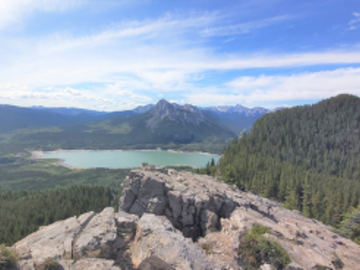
[119,165,240,240]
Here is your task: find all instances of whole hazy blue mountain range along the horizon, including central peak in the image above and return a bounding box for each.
[0,99,269,143]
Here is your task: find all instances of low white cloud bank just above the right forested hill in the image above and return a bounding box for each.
[186,68,360,106]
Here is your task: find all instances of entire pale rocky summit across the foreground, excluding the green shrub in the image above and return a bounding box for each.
[13,165,360,270]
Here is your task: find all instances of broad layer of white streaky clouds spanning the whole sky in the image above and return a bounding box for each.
[0,0,360,110]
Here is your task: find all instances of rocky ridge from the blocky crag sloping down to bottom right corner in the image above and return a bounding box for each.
[119,165,360,269]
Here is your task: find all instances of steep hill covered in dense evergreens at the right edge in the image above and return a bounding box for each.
[218,95,360,243]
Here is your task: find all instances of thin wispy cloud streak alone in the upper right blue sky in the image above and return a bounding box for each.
[201,15,290,37]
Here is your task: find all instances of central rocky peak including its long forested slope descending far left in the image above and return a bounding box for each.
[7,100,236,149]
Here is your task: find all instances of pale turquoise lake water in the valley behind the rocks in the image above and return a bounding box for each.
[39,150,220,169]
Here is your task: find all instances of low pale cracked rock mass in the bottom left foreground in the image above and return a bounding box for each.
[13,207,138,269]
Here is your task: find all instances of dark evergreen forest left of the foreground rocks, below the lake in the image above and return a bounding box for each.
[0,186,119,245]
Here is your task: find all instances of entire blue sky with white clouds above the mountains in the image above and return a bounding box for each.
[0,0,360,111]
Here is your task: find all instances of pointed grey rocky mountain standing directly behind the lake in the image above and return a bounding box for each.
[97,100,235,144]
